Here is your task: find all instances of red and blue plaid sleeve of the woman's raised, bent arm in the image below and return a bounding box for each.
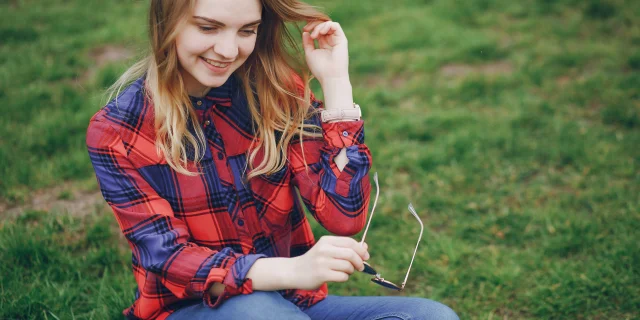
[288,91,372,236]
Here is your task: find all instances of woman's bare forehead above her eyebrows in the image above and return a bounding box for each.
[193,0,262,27]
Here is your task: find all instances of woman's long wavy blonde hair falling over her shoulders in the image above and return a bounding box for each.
[108,0,329,179]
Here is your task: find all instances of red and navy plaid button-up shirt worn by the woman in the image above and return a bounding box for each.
[87,77,371,319]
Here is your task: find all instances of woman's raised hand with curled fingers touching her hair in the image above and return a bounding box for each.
[302,21,349,84]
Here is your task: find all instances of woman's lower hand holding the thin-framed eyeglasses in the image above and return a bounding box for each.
[292,236,369,290]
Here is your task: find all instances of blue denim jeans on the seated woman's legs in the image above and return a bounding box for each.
[168,291,458,320]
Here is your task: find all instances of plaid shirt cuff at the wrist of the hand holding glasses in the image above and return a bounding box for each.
[203,254,267,308]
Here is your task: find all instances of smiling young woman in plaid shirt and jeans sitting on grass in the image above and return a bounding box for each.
[87,0,457,319]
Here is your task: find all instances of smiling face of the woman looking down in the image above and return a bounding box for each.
[176,0,262,96]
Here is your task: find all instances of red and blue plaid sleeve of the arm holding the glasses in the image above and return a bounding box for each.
[87,119,264,312]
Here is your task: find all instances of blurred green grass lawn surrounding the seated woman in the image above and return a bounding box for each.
[0,0,640,319]
